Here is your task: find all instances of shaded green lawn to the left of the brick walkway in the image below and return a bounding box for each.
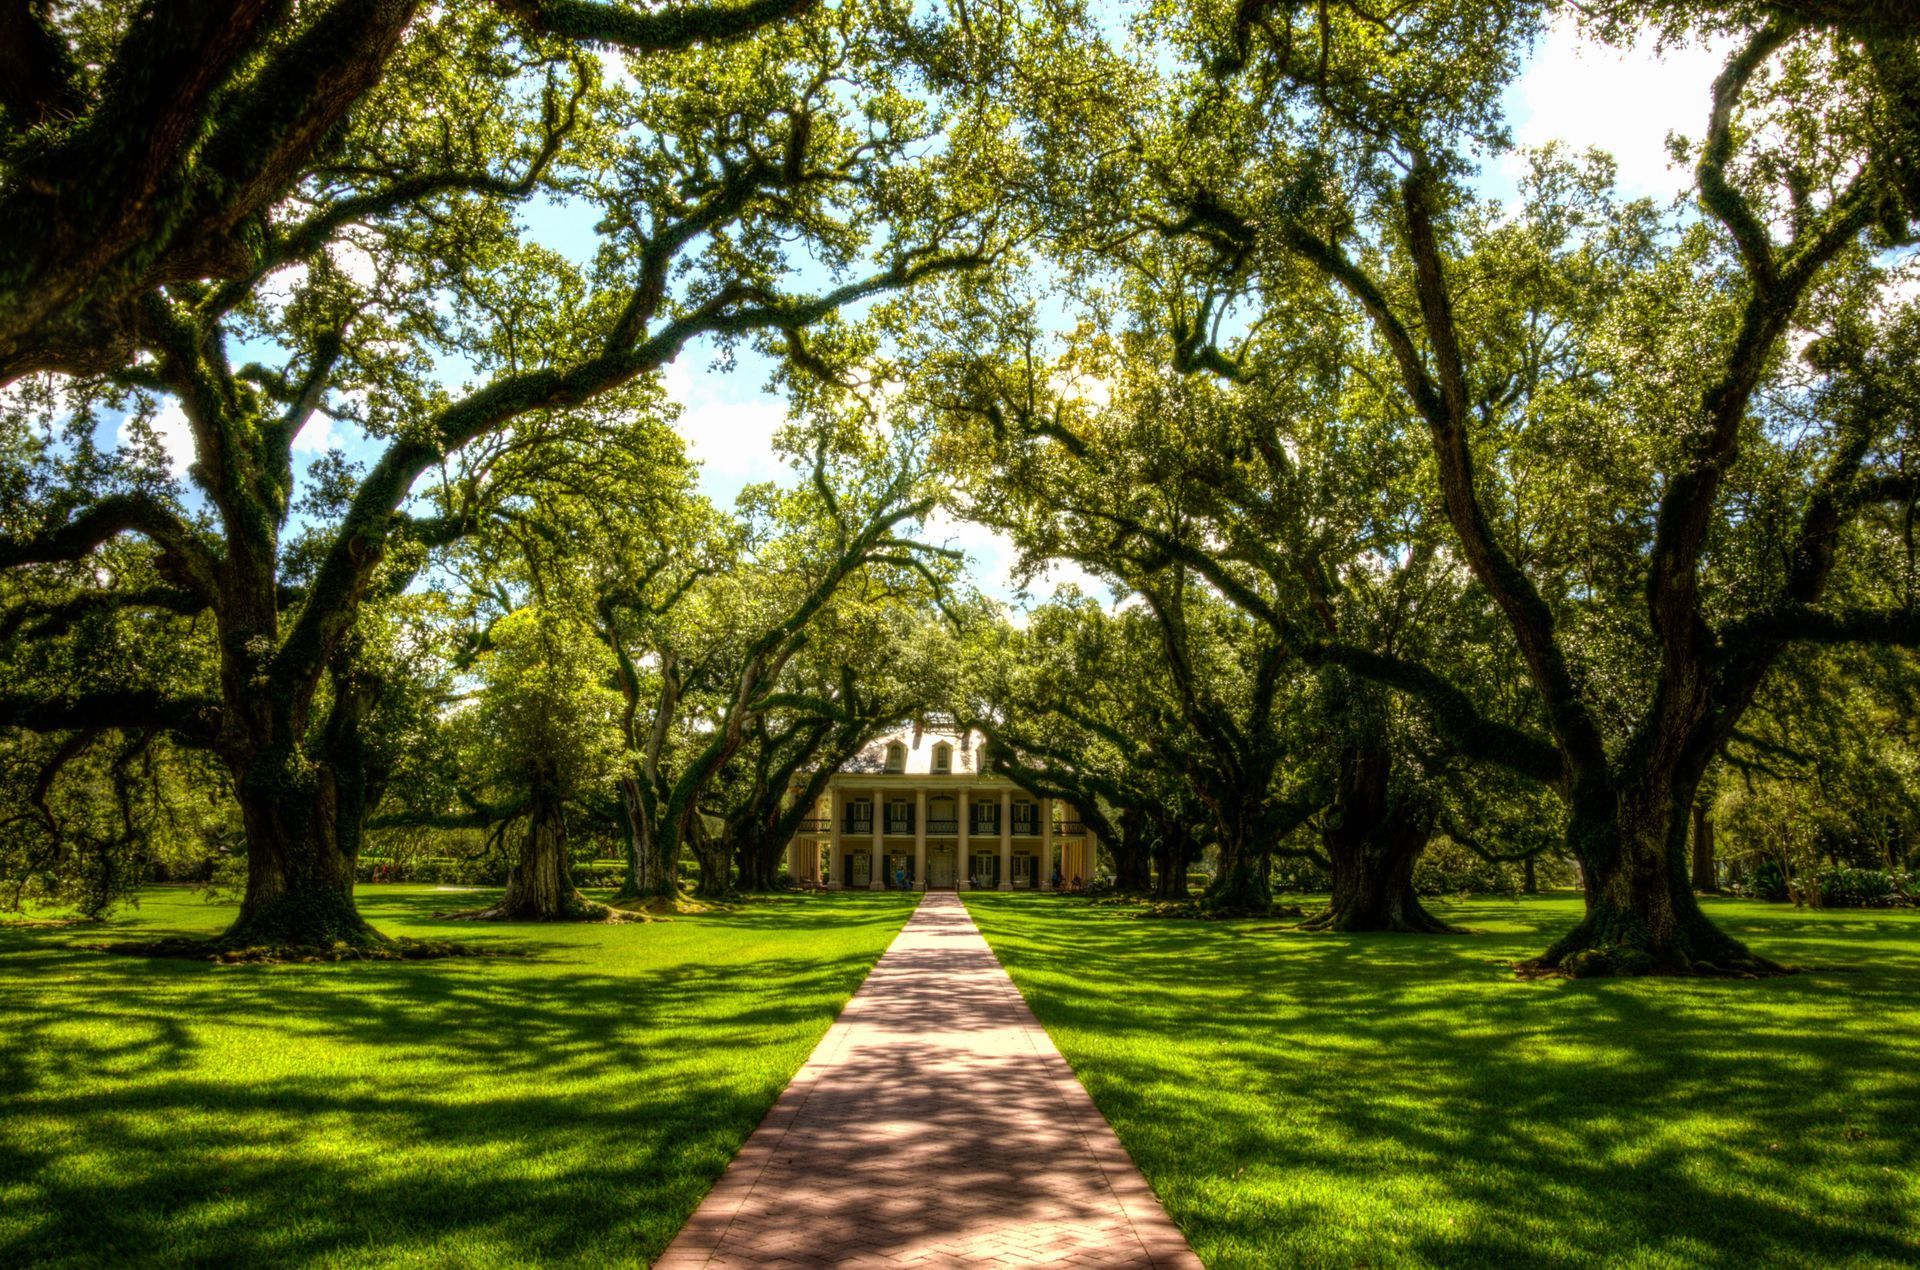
[0,886,908,1266]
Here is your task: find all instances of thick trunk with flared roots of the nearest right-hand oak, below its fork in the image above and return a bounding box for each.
[1521,782,1786,976]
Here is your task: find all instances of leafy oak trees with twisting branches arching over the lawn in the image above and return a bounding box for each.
[0,0,1920,974]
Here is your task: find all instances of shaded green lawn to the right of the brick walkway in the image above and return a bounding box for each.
[968,895,1920,1268]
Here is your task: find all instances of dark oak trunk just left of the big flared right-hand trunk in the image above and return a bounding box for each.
[1302,745,1459,934]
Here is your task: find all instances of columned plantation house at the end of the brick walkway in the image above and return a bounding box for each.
[787,728,1096,891]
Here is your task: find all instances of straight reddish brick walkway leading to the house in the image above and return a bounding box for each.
[659,891,1200,1268]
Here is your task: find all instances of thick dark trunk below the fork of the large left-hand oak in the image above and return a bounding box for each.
[217,755,392,949]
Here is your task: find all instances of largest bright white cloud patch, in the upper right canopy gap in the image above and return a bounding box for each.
[1501,17,1728,202]
